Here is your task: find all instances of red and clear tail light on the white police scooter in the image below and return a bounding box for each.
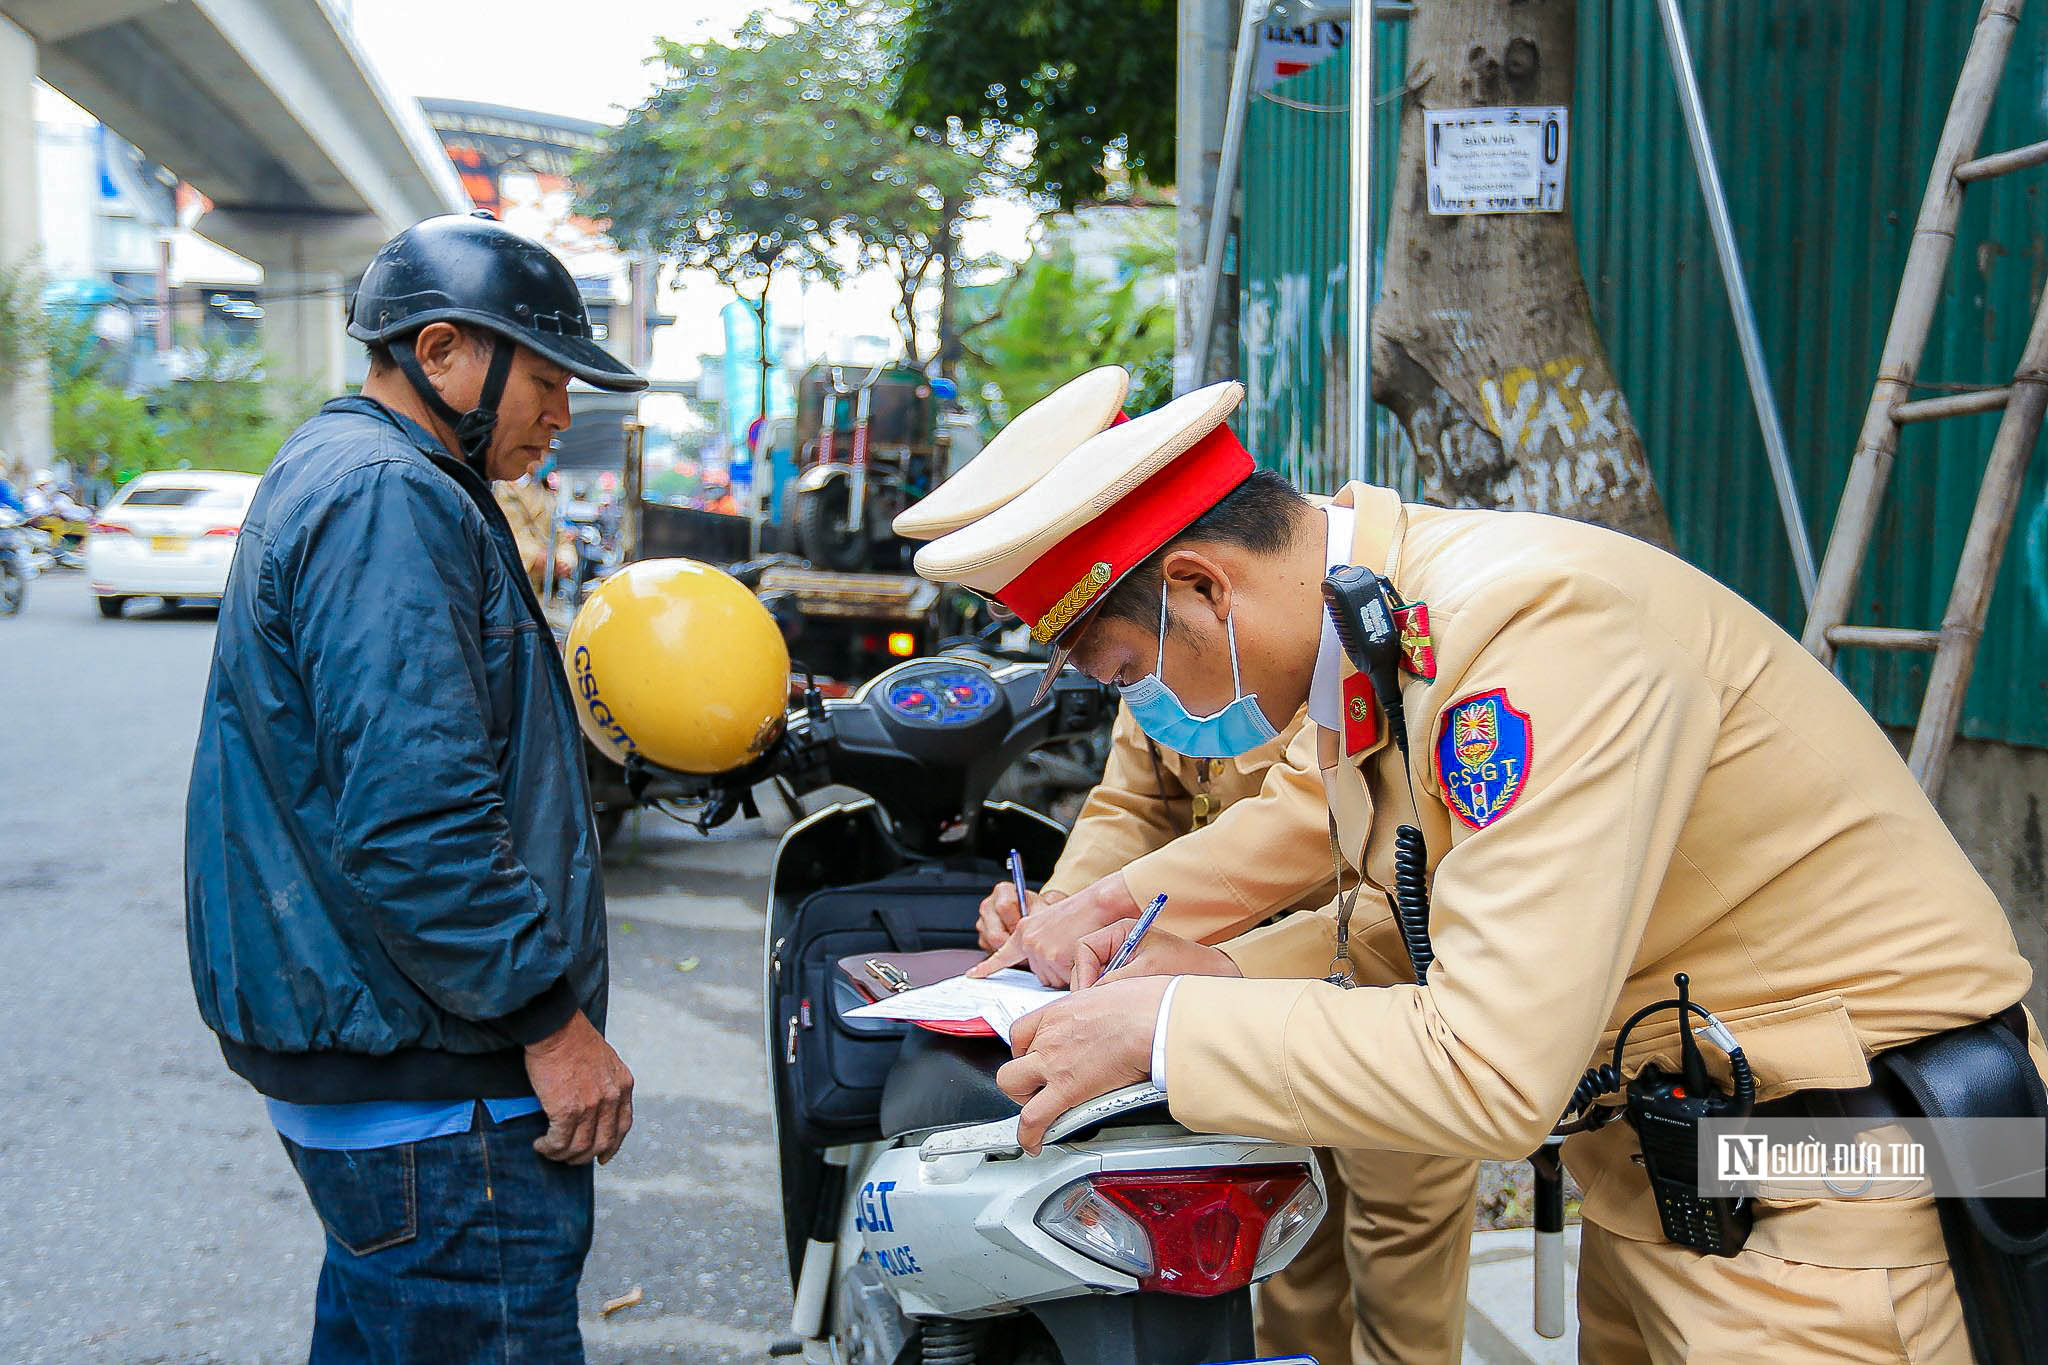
[1038,1162,1323,1297]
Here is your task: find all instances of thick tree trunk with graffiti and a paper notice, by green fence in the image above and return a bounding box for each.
[1372,0,1671,546]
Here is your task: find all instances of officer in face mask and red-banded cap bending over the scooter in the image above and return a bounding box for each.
[918,385,2048,1361]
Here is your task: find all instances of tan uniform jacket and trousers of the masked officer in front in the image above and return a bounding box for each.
[1165,485,2044,1361]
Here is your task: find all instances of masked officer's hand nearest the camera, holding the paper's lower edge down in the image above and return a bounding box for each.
[995,978,1167,1156]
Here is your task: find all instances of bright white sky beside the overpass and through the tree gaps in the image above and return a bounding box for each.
[336,0,1030,379]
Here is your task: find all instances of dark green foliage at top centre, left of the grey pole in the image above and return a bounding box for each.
[895,0,1176,209]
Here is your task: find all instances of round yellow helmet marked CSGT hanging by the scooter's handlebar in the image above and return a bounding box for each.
[567,559,788,774]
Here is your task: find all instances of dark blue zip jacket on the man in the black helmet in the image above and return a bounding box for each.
[184,397,606,1103]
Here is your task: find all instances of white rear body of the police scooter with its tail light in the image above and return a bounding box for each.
[793,1080,1325,1365]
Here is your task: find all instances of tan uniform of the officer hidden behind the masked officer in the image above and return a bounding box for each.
[1044,708,1479,1365]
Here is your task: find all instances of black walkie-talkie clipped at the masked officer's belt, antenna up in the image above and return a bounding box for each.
[1626,972,1755,1257]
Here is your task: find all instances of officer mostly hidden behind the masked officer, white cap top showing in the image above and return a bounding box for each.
[895,366,1479,1365]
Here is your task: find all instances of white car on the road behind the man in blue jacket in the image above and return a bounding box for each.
[86,469,256,616]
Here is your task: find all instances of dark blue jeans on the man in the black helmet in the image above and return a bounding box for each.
[281,1105,592,1365]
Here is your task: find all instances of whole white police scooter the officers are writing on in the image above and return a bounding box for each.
[629,651,1325,1365]
